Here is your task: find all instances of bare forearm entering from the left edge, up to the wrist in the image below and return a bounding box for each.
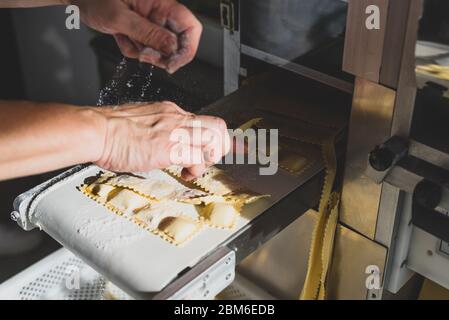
[0,101,106,180]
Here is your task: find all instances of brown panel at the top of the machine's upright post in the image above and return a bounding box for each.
[343,0,390,82]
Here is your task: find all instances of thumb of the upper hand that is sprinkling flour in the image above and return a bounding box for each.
[119,10,178,56]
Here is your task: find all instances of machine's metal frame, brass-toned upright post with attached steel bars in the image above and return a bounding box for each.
[222,0,449,299]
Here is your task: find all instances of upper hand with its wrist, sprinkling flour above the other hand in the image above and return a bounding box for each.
[68,0,202,73]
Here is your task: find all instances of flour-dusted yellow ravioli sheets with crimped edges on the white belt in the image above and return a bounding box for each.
[79,168,263,245]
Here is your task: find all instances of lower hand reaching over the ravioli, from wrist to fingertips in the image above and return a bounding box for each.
[95,102,230,180]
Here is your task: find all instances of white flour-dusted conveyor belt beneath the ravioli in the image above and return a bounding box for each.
[13,163,322,294]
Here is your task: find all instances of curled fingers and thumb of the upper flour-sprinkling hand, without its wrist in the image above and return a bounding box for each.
[116,3,202,73]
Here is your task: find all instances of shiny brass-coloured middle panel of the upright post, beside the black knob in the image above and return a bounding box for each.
[340,78,396,239]
